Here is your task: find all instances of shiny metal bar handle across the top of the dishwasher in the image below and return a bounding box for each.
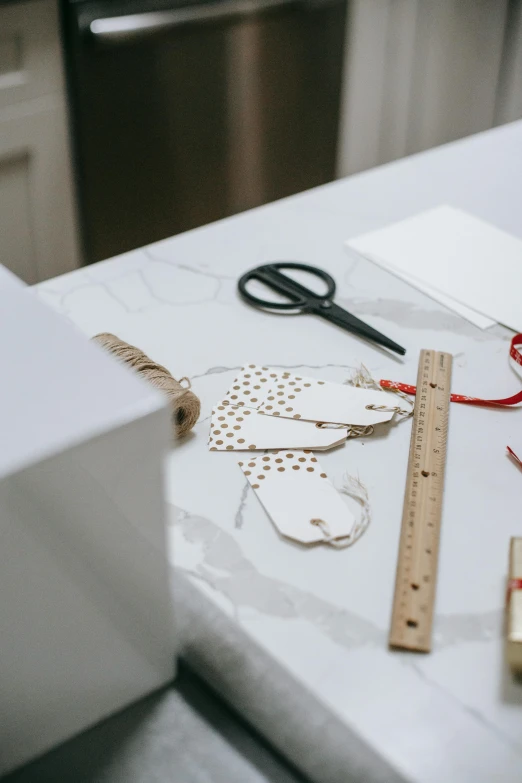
[89,0,310,43]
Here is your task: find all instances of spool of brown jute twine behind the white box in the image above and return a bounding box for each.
[92,332,201,438]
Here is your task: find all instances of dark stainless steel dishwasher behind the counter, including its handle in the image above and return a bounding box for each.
[64,0,345,262]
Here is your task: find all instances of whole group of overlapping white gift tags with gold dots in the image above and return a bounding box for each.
[208,364,401,543]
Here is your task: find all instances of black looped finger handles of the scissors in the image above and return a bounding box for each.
[237,261,335,311]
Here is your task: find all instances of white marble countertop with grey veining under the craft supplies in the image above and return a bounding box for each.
[38,123,522,783]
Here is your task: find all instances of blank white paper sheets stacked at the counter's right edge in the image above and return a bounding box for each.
[347,206,522,331]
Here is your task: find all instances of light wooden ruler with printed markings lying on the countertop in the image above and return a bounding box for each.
[389,350,452,652]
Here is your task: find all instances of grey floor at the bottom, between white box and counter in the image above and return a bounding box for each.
[2,664,306,783]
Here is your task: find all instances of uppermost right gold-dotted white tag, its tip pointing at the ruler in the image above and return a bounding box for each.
[255,373,397,426]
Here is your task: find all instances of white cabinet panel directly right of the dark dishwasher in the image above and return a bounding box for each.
[338,0,508,176]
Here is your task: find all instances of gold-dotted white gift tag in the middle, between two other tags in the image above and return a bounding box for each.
[208,400,348,451]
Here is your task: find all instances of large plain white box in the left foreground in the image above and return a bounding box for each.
[0,267,175,775]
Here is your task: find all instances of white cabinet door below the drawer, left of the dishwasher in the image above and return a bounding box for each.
[0,96,78,283]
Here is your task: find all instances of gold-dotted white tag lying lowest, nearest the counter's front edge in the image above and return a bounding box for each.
[239,451,354,544]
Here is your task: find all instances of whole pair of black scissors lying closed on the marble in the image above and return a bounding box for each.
[237,261,406,356]
